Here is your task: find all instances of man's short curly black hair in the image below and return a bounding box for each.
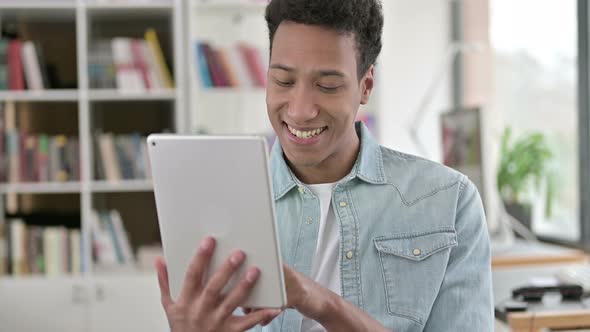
[265,0,383,79]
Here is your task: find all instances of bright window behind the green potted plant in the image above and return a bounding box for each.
[489,0,590,242]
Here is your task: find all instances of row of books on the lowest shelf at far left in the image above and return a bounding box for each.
[0,219,82,276]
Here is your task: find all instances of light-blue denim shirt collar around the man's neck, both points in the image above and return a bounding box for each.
[271,121,386,200]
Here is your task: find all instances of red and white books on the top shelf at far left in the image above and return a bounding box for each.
[0,39,50,90]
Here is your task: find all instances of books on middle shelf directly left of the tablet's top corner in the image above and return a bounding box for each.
[95,133,151,181]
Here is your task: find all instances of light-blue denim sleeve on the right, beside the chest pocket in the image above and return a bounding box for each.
[424,178,494,332]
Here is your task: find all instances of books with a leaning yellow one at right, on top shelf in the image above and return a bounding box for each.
[88,28,174,92]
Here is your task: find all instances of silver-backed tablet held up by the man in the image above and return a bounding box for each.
[147,134,287,308]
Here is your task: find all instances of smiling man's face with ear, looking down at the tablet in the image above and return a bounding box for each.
[266,22,373,169]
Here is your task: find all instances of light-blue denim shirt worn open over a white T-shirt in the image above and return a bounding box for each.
[258,122,494,332]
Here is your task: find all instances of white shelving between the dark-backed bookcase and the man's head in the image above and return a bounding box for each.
[186,0,272,135]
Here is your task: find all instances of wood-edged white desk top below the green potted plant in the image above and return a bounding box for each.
[492,239,588,269]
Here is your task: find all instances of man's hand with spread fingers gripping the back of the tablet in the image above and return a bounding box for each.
[156,238,281,332]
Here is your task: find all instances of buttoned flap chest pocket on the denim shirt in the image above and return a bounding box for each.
[374,228,457,324]
